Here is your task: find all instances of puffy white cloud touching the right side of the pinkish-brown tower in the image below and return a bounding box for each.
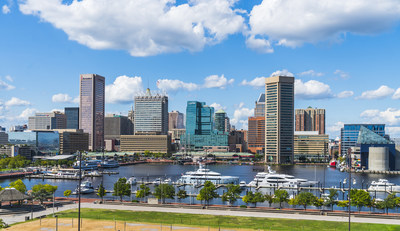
[105,75,143,103]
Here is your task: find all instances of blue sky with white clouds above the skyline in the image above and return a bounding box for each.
[0,0,400,138]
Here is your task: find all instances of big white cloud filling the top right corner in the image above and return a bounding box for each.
[249,0,400,51]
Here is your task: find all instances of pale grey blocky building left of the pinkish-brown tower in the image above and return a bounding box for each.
[28,111,67,130]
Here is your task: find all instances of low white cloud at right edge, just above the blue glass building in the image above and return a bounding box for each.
[360,108,400,125]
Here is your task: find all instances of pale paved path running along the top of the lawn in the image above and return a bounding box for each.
[1,203,400,225]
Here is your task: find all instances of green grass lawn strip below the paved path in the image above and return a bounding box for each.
[57,208,400,231]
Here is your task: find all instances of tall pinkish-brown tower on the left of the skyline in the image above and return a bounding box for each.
[79,74,105,151]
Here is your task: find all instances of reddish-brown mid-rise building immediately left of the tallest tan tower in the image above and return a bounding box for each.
[247,117,265,154]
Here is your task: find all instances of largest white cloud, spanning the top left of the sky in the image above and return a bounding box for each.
[19,0,246,56]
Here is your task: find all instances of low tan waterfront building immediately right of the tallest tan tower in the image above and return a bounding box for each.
[294,131,329,161]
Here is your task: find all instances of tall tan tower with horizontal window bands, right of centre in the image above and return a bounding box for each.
[265,76,294,164]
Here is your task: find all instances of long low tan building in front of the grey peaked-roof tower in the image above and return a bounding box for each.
[121,135,171,153]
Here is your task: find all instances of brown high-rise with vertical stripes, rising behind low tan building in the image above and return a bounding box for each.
[295,107,325,134]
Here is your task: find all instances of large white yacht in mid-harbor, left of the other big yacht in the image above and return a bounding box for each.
[177,163,239,185]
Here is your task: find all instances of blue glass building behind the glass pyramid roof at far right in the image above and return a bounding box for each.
[340,124,385,155]
